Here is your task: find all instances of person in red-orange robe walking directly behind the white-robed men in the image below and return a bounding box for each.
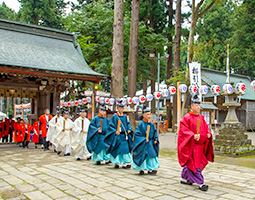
[39,108,52,151]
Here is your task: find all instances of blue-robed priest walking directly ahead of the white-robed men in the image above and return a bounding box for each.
[86,106,110,165]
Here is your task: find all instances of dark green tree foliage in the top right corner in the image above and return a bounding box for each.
[230,0,255,77]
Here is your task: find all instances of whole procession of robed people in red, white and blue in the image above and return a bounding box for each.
[0,97,214,191]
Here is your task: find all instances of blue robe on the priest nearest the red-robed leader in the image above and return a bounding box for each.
[132,120,159,170]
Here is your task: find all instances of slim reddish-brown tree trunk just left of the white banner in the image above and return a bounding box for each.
[172,0,181,132]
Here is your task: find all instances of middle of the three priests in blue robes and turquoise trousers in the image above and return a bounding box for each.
[105,101,133,168]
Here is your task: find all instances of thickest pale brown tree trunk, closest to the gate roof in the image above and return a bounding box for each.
[111,0,124,98]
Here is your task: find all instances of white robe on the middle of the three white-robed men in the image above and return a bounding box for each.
[53,119,78,147]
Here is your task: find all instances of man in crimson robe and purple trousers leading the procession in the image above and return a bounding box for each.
[177,95,214,191]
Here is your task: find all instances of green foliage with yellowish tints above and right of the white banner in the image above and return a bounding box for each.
[194,1,236,70]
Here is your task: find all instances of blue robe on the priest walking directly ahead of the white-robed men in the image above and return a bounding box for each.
[86,115,109,161]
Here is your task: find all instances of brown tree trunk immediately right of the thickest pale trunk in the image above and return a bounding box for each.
[127,0,140,127]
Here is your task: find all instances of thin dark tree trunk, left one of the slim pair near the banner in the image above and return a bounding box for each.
[166,0,173,128]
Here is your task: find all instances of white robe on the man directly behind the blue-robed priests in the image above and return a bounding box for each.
[72,117,91,158]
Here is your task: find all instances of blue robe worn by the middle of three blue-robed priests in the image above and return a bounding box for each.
[105,114,133,164]
